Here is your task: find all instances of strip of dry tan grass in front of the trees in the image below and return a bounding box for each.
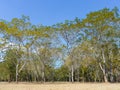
[0,83,120,90]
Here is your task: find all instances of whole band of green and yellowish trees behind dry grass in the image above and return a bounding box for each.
[0,7,120,82]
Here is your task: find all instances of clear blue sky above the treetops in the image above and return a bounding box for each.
[0,0,120,25]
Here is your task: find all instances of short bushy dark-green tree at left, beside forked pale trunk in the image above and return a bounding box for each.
[4,49,22,81]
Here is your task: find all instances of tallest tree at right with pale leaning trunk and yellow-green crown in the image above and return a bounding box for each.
[83,8,118,82]
